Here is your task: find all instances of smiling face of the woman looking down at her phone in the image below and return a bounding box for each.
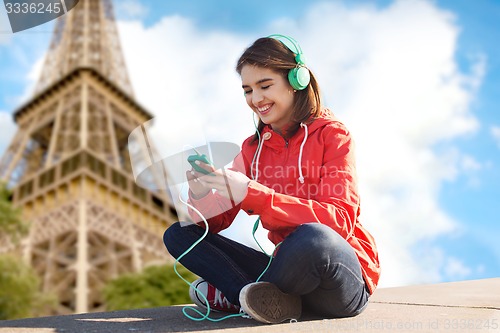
[241,65,294,133]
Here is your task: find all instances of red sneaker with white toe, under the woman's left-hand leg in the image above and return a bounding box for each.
[189,278,240,313]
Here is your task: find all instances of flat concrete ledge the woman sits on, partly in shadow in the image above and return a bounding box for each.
[0,278,500,333]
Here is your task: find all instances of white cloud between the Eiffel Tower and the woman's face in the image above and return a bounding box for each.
[119,16,253,155]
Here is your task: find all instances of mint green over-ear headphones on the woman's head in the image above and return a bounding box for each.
[267,34,311,90]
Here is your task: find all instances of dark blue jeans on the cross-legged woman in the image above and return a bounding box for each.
[163,222,369,318]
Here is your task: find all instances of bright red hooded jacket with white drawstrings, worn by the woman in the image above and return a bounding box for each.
[190,109,380,293]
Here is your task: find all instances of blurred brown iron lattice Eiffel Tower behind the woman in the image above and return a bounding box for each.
[0,0,176,314]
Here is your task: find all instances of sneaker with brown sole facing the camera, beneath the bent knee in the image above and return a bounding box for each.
[240,282,302,324]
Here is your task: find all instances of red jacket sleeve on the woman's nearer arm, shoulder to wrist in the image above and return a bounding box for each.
[241,127,359,239]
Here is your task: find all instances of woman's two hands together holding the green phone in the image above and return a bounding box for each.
[186,161,250,204]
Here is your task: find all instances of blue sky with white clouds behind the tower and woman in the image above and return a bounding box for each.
[0,0,500,286]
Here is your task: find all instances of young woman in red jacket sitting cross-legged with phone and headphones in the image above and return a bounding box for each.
[164,35,380,323]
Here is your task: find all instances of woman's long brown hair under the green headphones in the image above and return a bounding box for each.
[236,37,321,141]
